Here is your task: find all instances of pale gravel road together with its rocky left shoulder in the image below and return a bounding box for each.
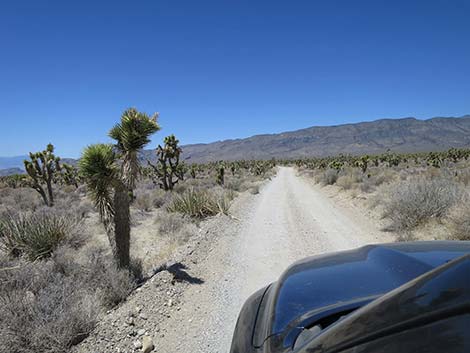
[76,168,393,353]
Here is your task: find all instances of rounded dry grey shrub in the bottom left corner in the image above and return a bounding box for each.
[0,261,100,353]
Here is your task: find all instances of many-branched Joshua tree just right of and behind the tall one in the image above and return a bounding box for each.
[147,135,184,190]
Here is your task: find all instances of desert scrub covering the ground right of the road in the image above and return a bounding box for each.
[295,148,470,240]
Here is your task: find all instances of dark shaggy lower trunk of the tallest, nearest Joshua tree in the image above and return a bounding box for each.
[111,185,131,268]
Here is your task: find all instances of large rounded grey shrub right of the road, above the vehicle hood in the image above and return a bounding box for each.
[383,178,461,229]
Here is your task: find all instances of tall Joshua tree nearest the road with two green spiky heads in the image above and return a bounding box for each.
[79,108,160,268]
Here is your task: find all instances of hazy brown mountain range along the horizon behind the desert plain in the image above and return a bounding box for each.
[0,115,470,174]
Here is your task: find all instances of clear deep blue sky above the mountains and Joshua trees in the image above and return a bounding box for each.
[0,0,470,157]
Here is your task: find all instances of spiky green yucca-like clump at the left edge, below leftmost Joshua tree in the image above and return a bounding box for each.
[0,212,79,260]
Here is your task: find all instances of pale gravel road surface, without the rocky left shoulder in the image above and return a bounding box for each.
[156,168,392,353]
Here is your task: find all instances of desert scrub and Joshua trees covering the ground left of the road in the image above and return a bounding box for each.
[0,109,276,353]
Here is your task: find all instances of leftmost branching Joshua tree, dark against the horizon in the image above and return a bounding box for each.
[24,143,60,207]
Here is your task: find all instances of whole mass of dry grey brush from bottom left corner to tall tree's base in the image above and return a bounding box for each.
[0,241,142,353]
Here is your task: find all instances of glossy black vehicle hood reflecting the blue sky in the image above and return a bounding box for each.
[253,241,470,352]
